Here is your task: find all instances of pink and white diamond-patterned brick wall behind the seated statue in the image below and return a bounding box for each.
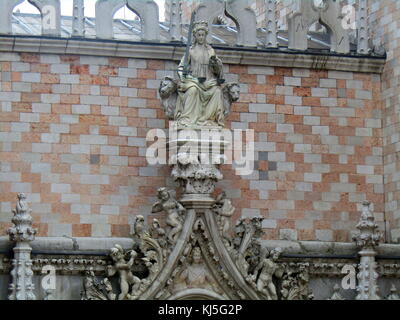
[0,53,384,241]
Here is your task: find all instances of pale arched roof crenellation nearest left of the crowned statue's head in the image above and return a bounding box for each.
[96,0,160,41]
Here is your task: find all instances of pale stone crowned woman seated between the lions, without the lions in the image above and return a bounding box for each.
[175,21,231,127]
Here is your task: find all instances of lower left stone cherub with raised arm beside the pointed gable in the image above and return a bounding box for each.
[107,244,140,300]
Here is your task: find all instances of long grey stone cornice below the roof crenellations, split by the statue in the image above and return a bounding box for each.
[0,35,386,73]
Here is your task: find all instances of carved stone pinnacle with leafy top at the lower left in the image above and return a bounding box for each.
[7,193,36,300]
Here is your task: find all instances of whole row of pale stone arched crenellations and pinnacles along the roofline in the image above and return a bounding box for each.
[0,0,371,55]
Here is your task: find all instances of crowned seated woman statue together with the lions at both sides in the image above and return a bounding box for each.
[158,21,240,127]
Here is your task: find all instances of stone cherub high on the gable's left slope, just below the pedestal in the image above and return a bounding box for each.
[152,188,186,243]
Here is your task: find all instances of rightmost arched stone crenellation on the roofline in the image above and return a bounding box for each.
[288,0,350,53]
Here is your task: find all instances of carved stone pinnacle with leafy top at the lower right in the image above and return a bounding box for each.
[353,201,382,300]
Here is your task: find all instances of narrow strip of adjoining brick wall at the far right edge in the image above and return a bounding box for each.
[369,0,400,242]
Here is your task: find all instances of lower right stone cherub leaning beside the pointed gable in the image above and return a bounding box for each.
[253,248,283,300]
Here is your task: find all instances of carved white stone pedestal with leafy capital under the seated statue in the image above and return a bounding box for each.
[168,127,231,209]
